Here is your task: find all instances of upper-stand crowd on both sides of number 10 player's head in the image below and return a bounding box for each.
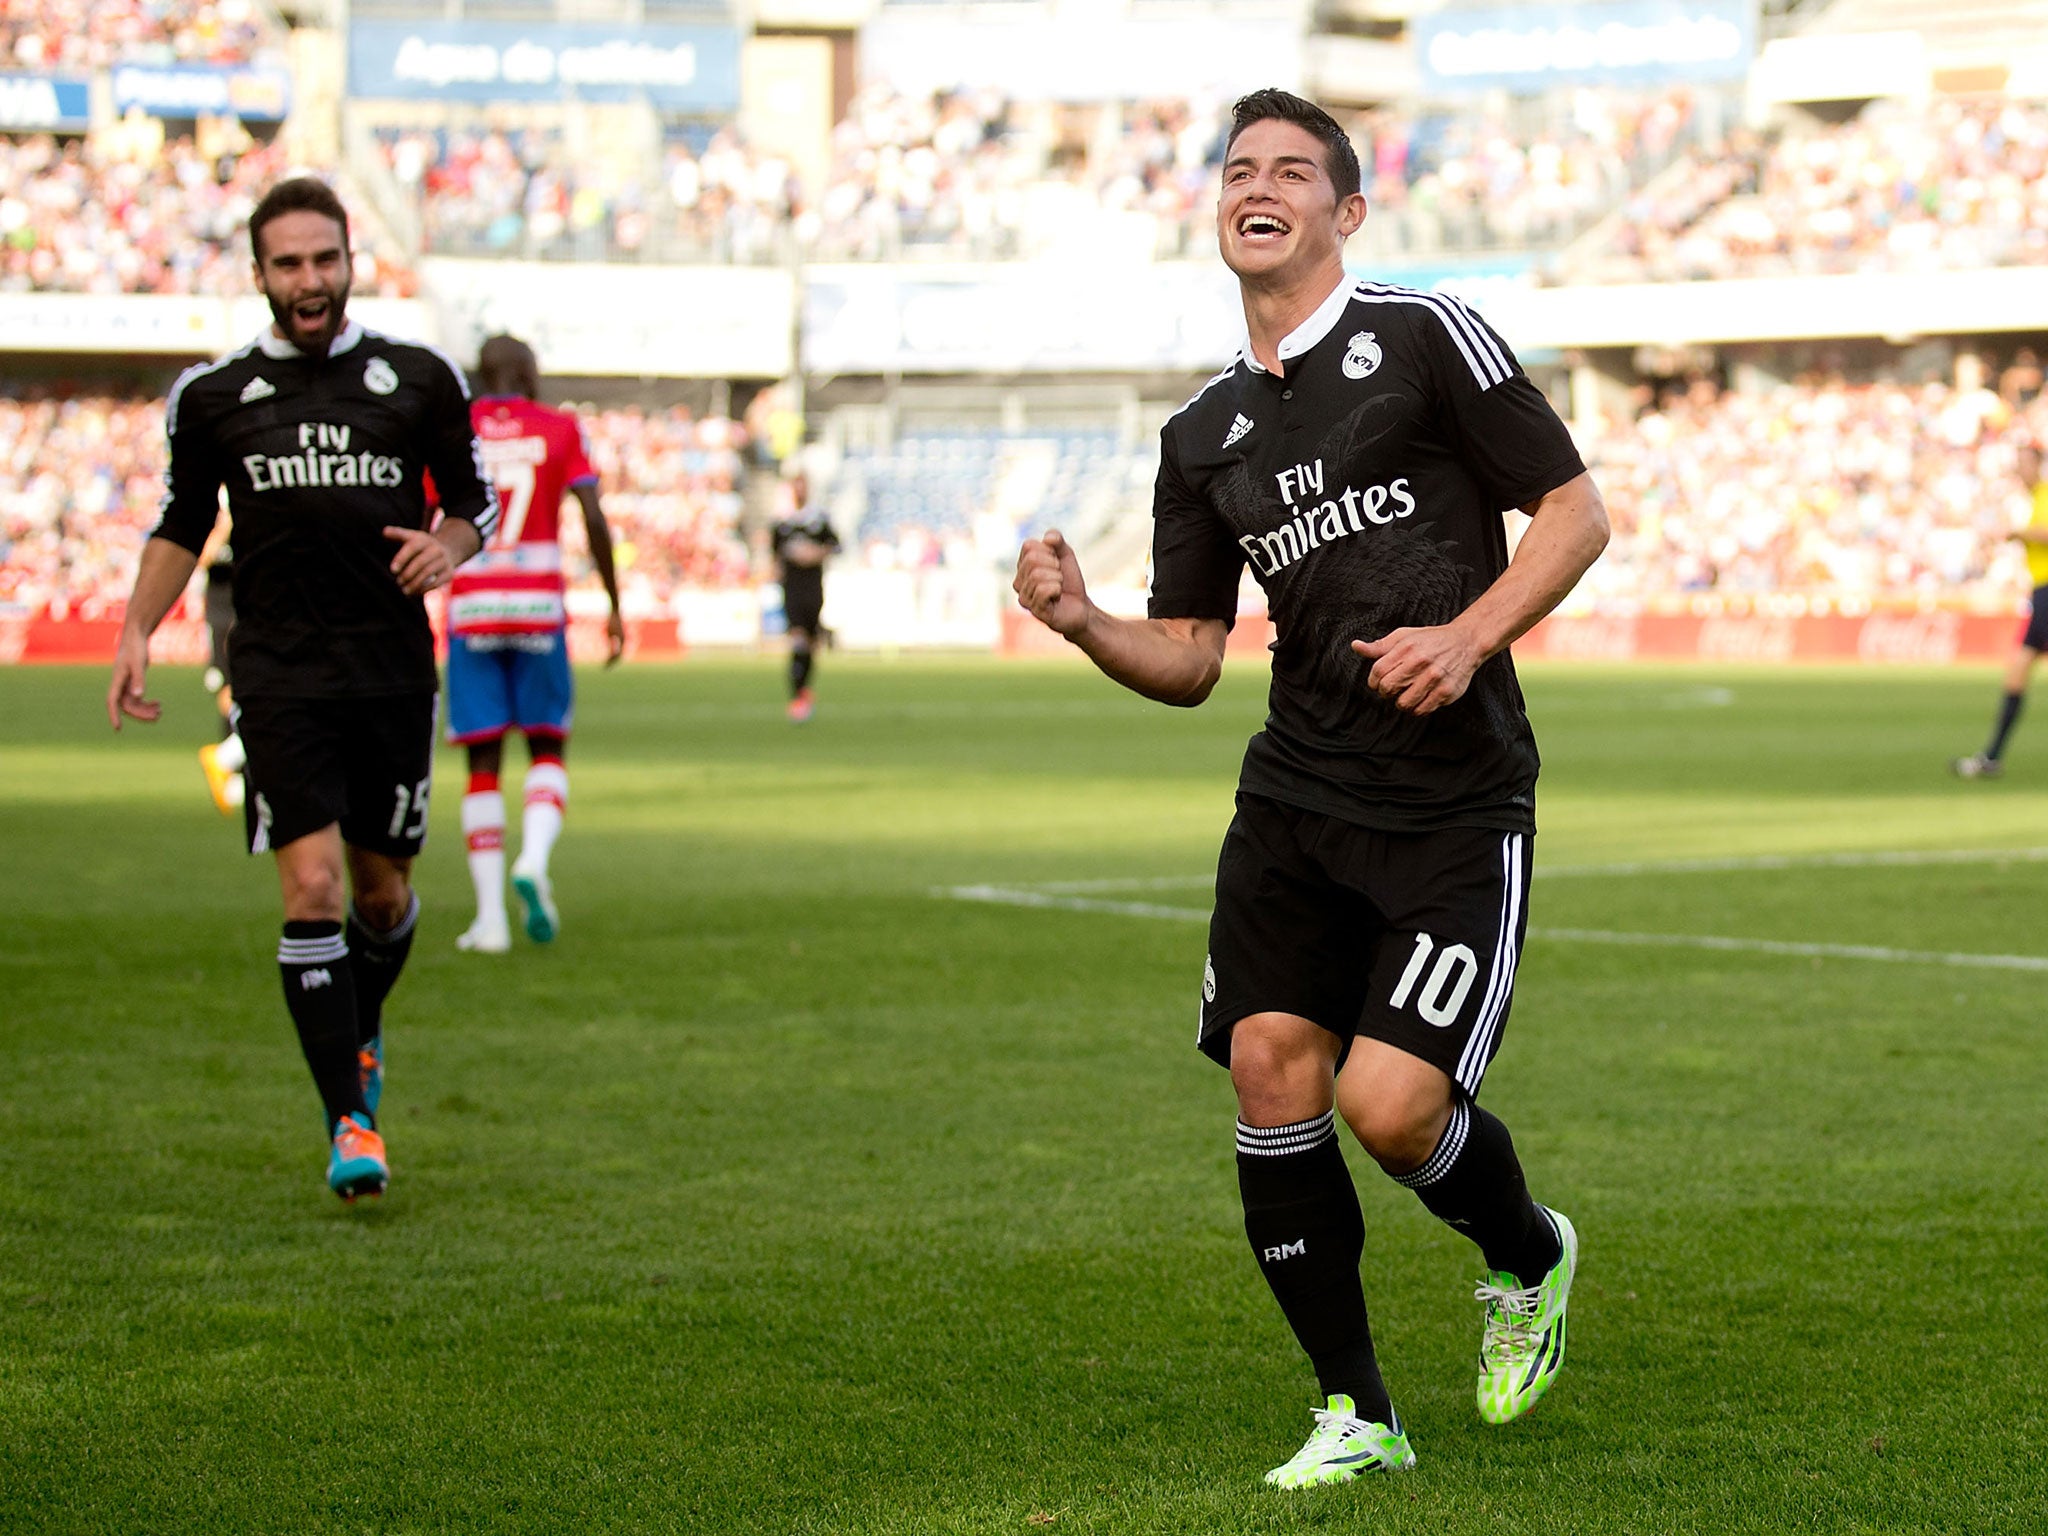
[381,86,1698,260]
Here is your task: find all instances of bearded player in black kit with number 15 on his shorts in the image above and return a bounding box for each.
[106,178,498,1200]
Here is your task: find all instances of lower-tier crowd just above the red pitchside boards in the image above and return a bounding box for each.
[24,372,2048,616]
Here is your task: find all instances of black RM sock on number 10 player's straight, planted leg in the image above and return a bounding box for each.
[1237,1114,1395,1425]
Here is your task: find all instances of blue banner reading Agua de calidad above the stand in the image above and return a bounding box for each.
[348,20,739,113]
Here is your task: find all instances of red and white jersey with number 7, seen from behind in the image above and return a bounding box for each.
[449,395,598,635]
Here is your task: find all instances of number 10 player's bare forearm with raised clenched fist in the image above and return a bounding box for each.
[1010,528,1229,707]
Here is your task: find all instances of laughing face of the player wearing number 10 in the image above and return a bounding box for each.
[1217,117,1366,283]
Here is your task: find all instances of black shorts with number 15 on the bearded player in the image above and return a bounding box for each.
[236,694,438,858]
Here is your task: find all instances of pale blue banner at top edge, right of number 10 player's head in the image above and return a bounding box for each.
[1413,0,1757,96]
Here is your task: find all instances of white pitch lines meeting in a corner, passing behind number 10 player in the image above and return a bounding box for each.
[932,848,2048,971]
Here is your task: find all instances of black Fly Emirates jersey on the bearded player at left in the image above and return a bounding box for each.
[154,322,498,698]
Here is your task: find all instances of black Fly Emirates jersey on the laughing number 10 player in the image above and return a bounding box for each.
[1149,279,1585,831]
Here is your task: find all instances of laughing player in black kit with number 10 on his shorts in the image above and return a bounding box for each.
[1016,90,1608,1487]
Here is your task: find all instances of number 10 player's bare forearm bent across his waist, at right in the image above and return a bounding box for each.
[1352,473,1608,715]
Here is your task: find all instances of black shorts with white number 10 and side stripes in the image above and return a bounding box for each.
[1198,795,1532,1096]
